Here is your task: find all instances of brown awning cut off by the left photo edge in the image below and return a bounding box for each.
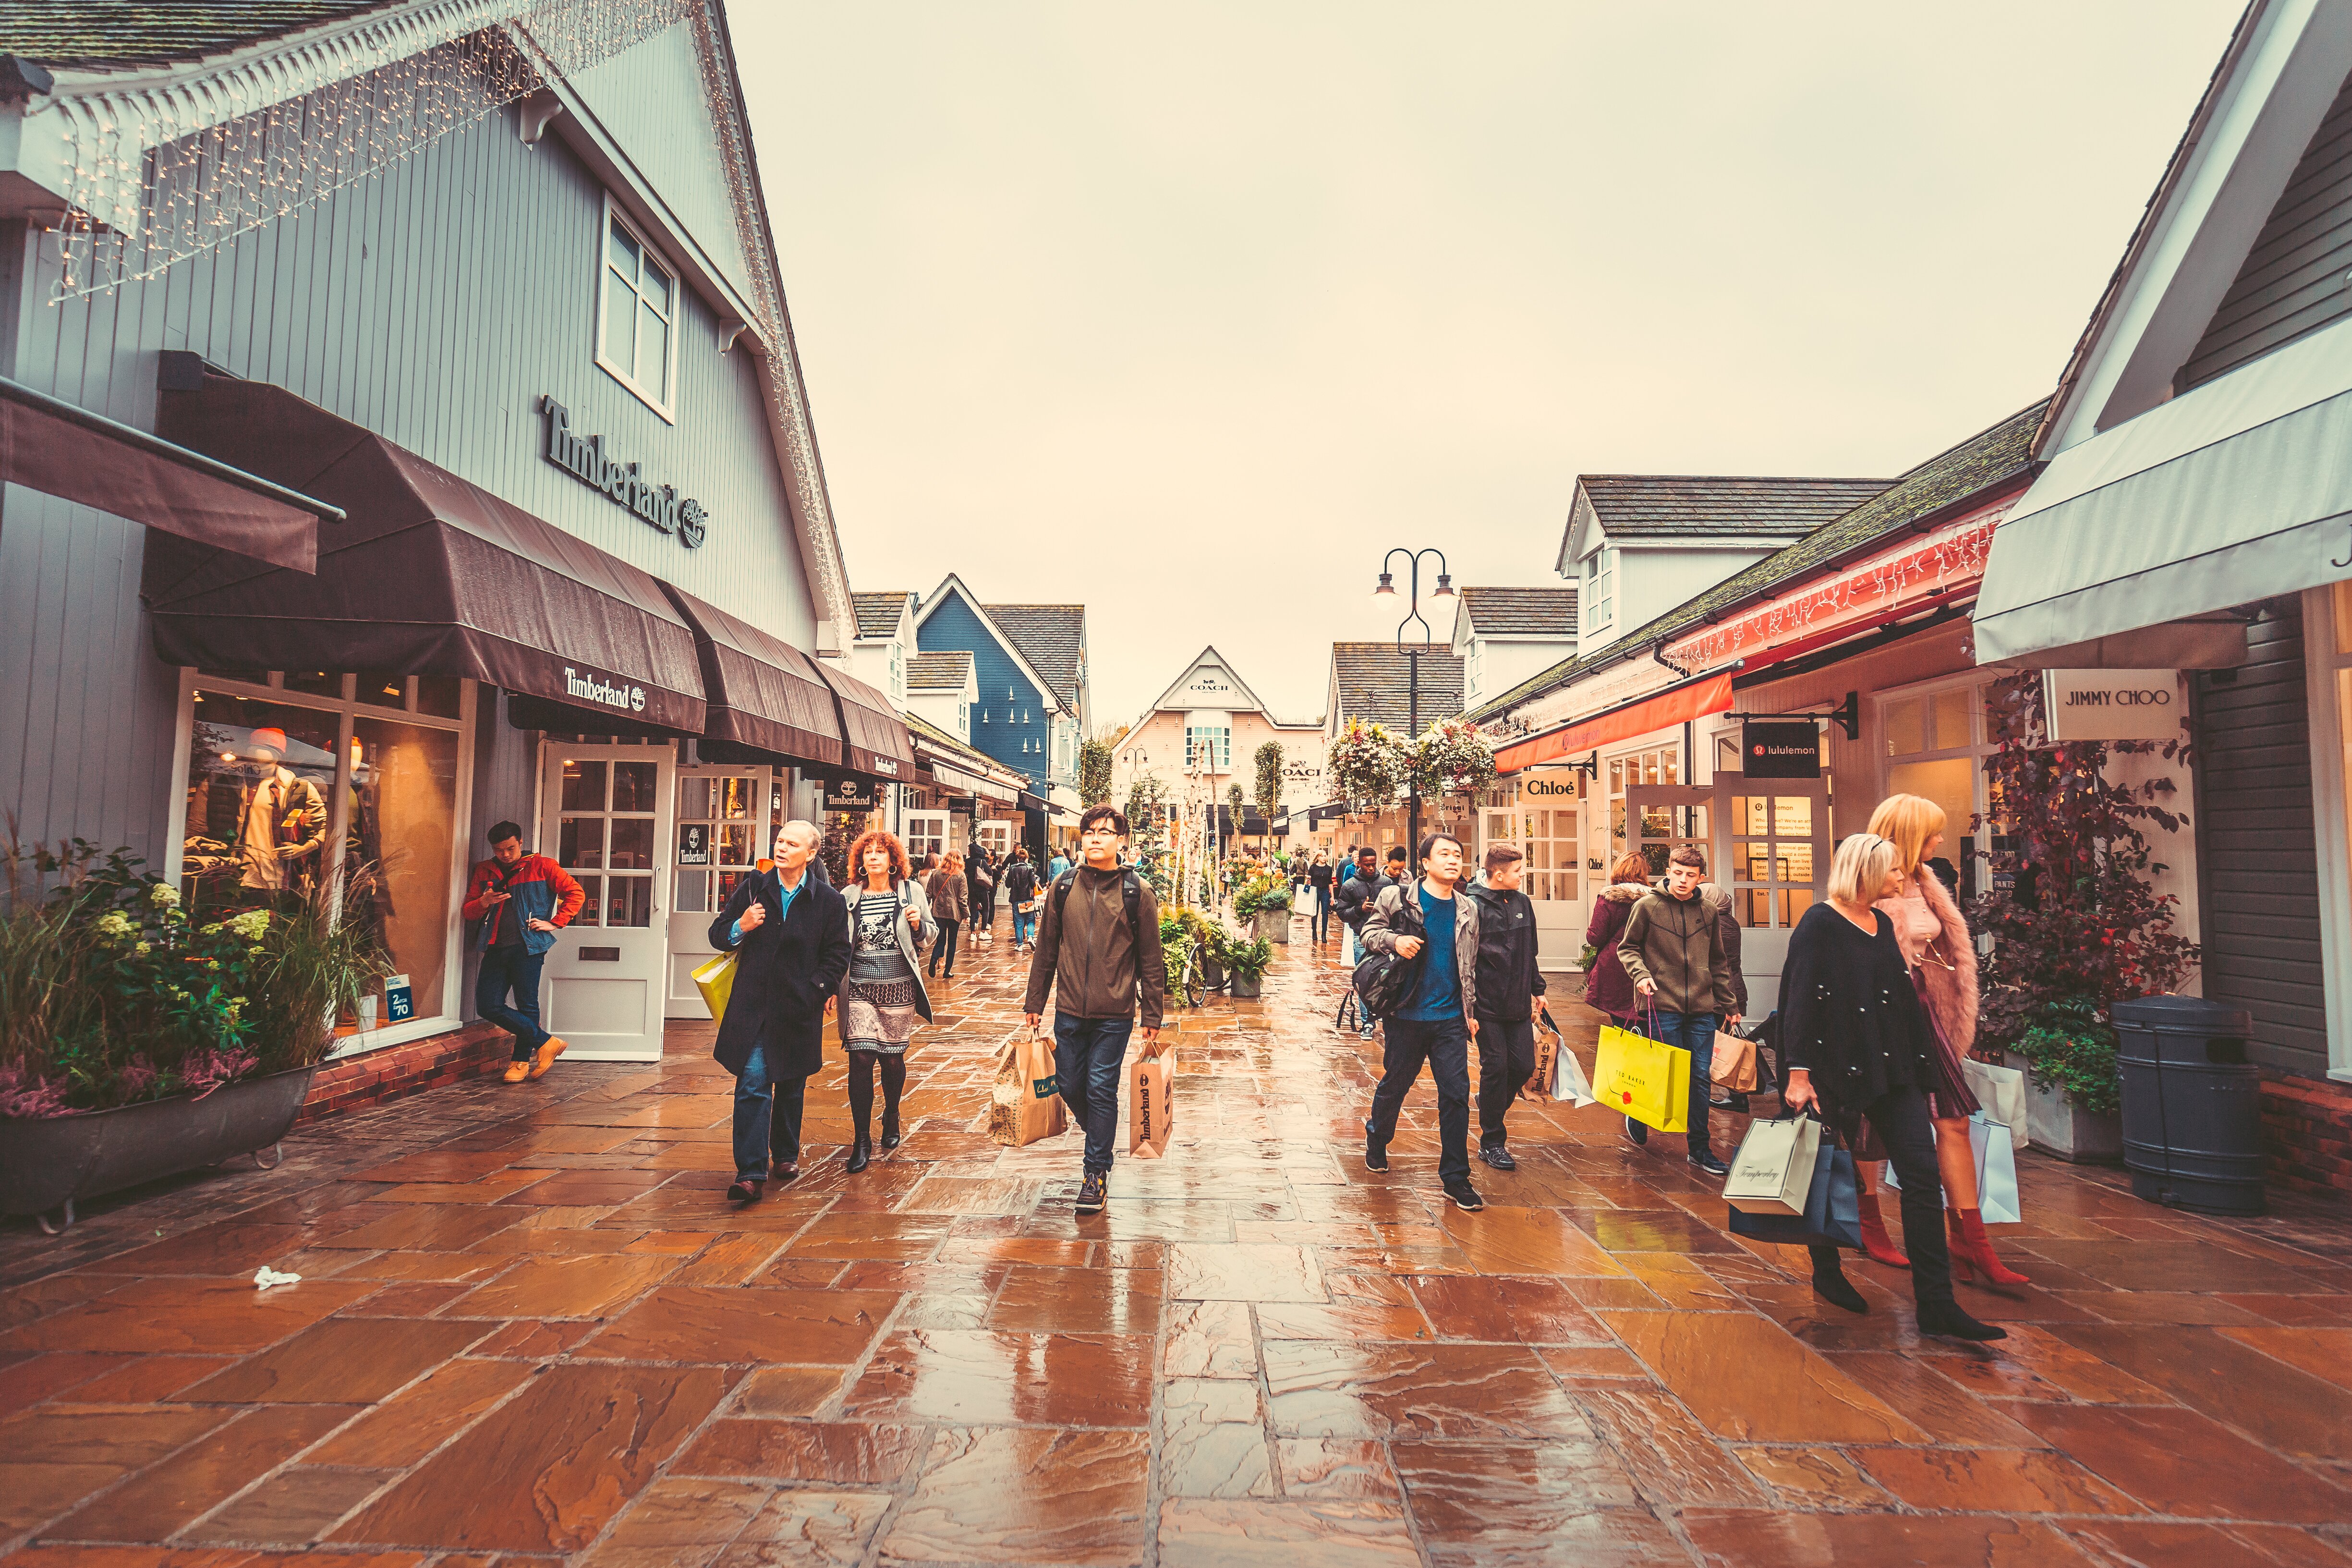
[0,376,343,571]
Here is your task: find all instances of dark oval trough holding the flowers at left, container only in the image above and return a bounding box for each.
[0,1067,317,1229]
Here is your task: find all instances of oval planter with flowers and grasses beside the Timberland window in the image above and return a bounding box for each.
[0,835,390,1229]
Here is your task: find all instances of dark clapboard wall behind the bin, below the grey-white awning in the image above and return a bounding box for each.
[2197,599,2328,1074]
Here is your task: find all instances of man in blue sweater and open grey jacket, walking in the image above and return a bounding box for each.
[1364,832,1487,1211]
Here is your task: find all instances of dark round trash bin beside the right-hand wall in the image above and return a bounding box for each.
[2112,997,2265,1213]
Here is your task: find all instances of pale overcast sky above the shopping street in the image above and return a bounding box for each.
[731,0,2239,724]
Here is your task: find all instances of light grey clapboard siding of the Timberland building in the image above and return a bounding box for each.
[0,83,819,861]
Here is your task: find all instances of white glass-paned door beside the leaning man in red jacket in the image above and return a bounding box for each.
[539,741,675,1063]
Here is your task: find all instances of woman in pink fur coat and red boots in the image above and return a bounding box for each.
[1870,795,2027,1286]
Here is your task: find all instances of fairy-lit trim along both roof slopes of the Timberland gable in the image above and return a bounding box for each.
[52,0,849,639]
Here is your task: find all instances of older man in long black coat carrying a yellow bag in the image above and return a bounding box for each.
[710,818,849,1203]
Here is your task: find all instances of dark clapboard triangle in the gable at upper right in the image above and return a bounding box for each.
[2176,78,2352,392]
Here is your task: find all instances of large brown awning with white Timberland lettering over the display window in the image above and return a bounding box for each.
[141,374,703,733]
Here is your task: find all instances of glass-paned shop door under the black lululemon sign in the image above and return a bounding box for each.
[1712,773,1830,1018]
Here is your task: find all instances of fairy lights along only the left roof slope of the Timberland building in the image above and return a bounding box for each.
[54,0,701,301]
